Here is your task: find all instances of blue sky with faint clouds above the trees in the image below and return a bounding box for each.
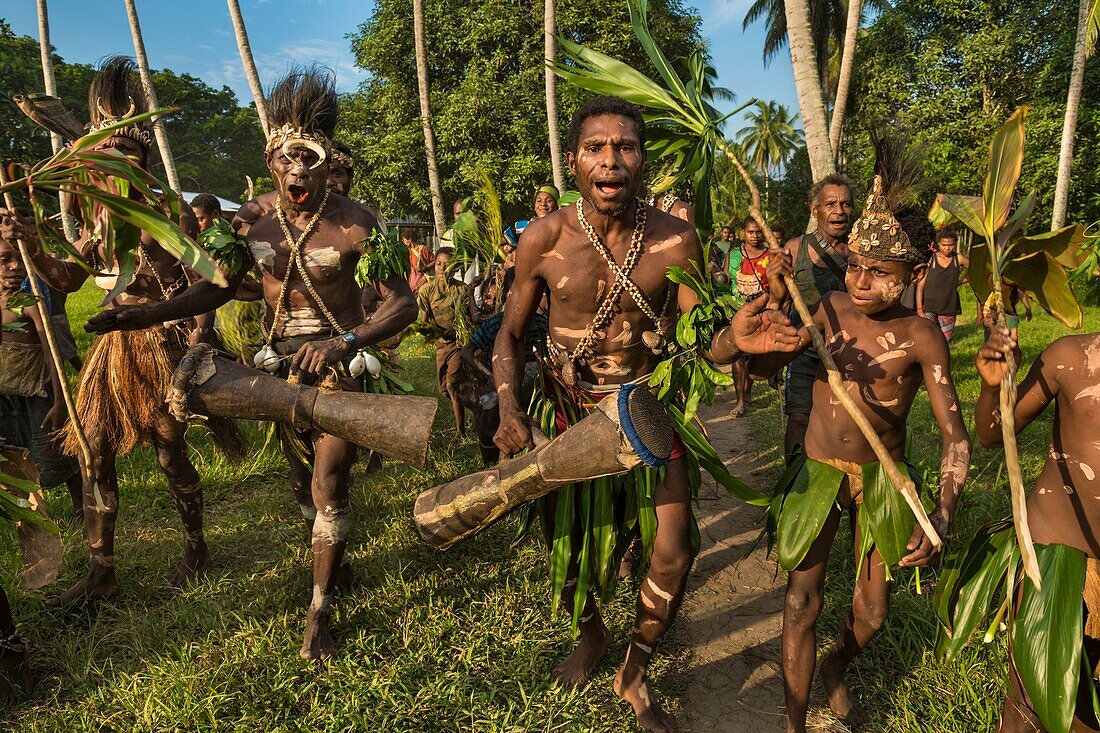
[0,0,798,122]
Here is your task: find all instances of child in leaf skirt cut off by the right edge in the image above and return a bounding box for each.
[934,326,1100,733]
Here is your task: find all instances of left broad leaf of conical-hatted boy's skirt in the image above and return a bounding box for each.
[776,459,845,571]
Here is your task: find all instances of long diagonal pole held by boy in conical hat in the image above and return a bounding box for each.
[718,138,943,548]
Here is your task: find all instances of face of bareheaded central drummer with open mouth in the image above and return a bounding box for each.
[567,114,646,216]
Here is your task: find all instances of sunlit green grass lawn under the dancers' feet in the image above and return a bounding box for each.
[0,280,1100,733]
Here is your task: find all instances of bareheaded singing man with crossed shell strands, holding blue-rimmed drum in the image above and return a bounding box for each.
[493,97,796,731]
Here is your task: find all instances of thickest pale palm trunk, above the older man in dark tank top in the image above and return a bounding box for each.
[783,0,836,180]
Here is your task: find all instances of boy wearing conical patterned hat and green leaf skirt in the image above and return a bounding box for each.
[734,177,970,732]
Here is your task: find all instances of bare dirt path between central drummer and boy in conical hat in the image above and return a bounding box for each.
[677,386,785,733]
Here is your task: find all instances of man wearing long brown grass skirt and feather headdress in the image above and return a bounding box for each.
[0,56,207,605]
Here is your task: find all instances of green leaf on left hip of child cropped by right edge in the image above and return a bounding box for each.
[932,521,1016,660]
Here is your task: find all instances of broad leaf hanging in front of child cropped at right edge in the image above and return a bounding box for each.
[1012,545,1086,733]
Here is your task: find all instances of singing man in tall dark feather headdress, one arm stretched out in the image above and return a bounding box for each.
[89,68,416,659]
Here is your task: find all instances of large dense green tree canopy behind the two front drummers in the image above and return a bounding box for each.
[338,0,703,222]
